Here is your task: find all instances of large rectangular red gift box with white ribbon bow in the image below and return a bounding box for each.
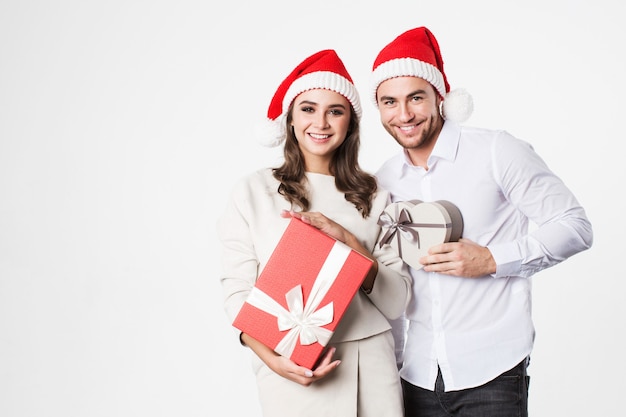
[233,218,372,369]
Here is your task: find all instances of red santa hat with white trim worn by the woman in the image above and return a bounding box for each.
[258,49,362,146]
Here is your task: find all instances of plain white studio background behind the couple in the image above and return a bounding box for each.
[0,0,626,417]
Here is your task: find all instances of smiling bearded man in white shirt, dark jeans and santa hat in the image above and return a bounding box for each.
[371,27,593,417]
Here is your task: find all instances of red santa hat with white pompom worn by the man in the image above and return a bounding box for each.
[371,27,474,123]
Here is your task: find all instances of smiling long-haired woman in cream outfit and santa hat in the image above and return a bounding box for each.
[218,50,411,417]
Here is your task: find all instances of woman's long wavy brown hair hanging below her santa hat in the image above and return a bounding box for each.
[272,104,377,217]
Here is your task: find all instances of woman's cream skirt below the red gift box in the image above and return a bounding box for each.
[253,331,404,417]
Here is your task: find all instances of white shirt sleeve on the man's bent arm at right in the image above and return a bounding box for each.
[488,133,593,278]
